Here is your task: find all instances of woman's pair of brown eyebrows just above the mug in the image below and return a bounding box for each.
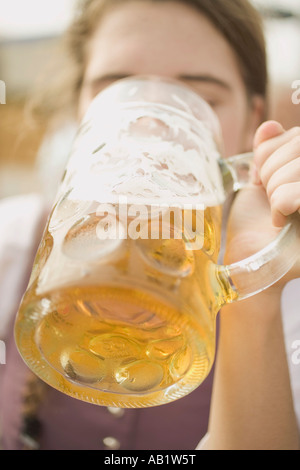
[86,73,232,90]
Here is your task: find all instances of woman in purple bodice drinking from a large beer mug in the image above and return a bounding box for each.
[1,0,300,450]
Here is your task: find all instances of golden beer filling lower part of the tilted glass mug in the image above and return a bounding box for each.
[15,202,234,407]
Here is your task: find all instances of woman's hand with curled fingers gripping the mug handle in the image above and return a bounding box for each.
[225,121,300,285]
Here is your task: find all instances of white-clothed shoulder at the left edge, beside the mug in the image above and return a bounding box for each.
[0,194,46,337]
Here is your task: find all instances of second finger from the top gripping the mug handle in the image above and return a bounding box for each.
[254,127,300,170]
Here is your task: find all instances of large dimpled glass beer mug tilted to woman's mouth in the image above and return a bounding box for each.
[15,77,299,407]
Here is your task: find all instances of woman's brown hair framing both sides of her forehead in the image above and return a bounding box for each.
[32,0,267,123]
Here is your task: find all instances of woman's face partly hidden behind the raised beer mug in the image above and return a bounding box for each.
[79,0,263,156]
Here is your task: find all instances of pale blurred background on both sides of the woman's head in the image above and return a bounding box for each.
[0,0,300,198]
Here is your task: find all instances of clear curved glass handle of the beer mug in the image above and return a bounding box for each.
[214,153,300,303]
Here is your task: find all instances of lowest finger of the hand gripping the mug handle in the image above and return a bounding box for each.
[270,182,300,227]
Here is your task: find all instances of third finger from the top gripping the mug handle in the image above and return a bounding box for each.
[259,137,300,188]
